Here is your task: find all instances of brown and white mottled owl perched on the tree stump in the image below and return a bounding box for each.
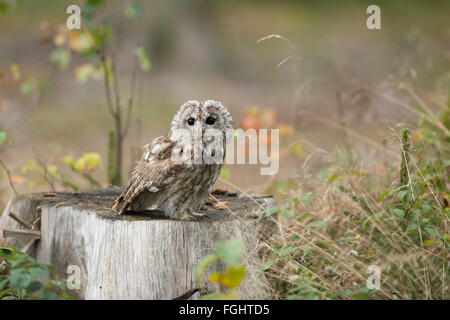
[113,100,233,220]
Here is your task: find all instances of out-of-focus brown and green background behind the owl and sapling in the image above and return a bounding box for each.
[0,0,450,196]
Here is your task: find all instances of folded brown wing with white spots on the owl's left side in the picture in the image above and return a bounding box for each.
[112,137,175,214]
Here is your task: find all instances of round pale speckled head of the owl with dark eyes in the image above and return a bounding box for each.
[169,100,233,144]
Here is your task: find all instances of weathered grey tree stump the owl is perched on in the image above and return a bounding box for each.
[0,188,273,299]
